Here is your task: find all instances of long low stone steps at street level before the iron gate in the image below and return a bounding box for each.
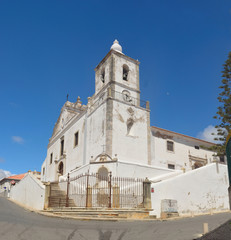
[42,207,156,221]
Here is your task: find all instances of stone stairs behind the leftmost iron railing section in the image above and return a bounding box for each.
[49,183,76,208]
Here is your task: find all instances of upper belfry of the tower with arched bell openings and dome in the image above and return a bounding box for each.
[95,40,140,105]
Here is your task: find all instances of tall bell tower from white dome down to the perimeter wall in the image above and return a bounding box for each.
[91,40,151,164]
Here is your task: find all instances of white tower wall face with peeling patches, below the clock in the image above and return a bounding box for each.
[112,101,149,164]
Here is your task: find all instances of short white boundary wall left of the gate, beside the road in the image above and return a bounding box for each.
[10,174,45,210]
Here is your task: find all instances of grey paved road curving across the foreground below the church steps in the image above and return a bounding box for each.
[0,197,231,240]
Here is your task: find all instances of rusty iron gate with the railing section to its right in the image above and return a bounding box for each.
[60,172,144,208]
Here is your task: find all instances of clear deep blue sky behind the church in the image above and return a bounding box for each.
[0,0,231,174]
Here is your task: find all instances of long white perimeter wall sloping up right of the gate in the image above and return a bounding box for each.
[151,163,229,217]
